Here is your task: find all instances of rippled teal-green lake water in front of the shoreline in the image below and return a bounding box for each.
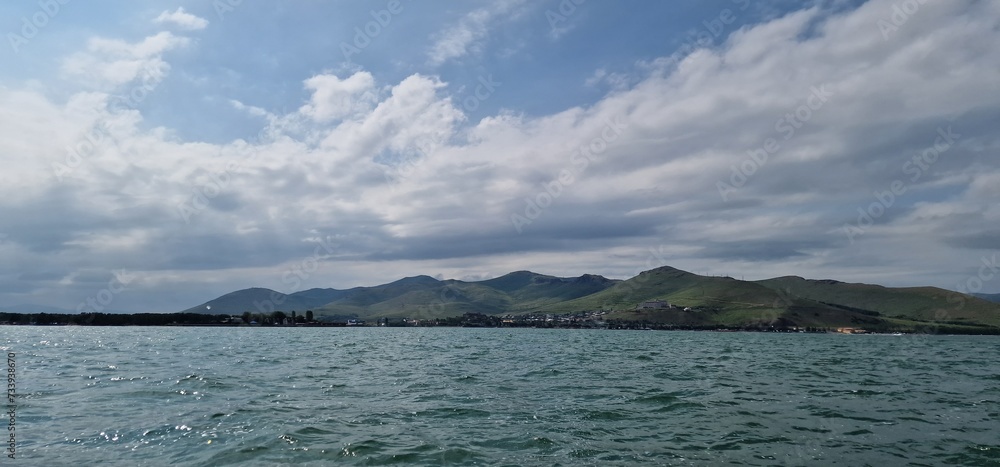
[0,326,1000,466]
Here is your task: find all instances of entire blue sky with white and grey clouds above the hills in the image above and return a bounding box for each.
[0,0,1000,312]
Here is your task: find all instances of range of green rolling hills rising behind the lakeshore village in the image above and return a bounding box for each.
[184,266,1000,332]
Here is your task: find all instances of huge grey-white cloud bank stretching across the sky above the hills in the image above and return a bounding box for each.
[0,1,1000,311]
